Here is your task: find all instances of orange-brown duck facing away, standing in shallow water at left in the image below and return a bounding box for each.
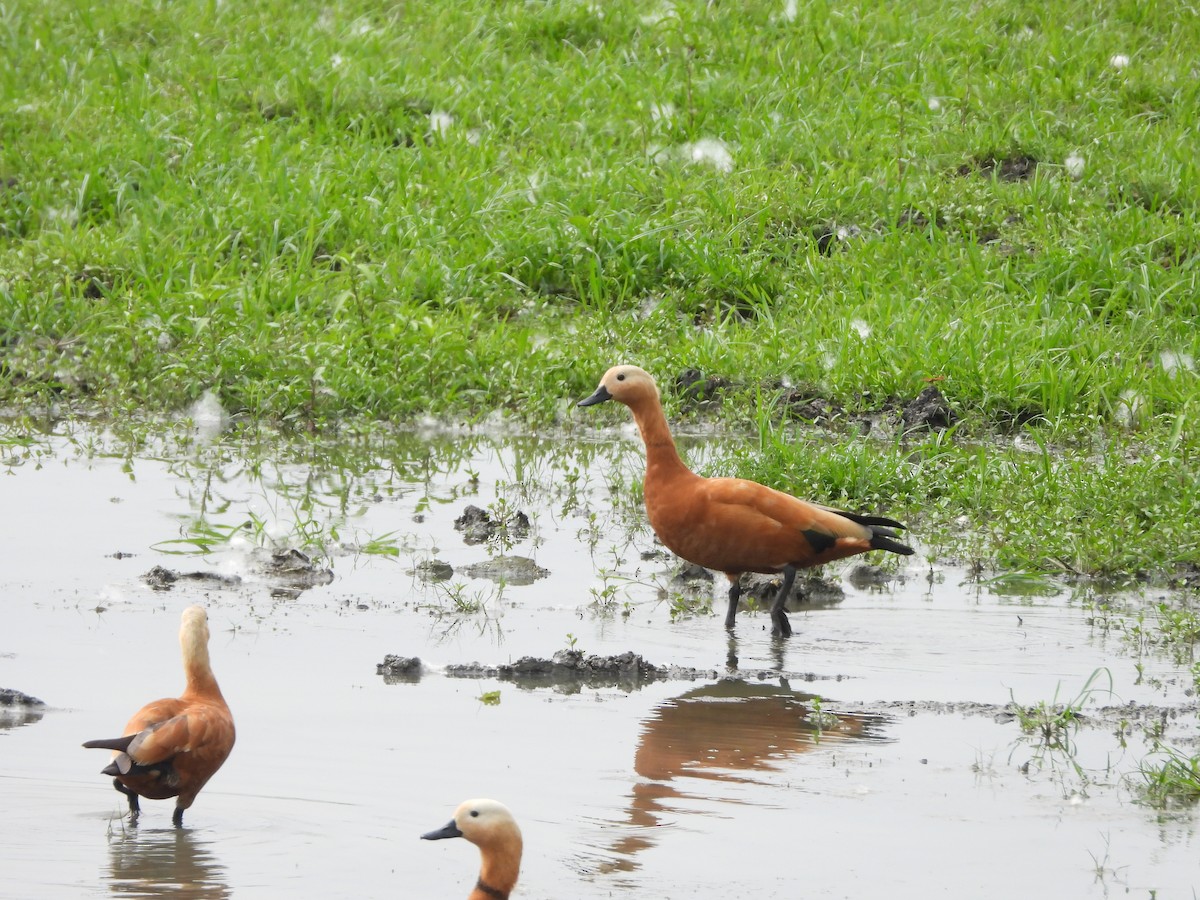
[84,606,234,827]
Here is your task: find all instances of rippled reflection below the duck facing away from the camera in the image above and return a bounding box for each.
[108,828,233,900]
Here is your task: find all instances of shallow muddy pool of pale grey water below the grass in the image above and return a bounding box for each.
[0,426,1200,900]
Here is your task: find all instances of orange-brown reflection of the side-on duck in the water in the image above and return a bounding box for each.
[600,679,888,872]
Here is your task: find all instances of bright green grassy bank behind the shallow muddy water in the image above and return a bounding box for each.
[0,0,1200,574]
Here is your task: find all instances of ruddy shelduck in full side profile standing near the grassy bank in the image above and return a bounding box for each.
[578,366,912,637]
